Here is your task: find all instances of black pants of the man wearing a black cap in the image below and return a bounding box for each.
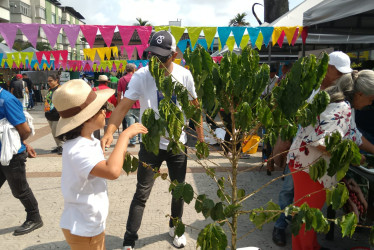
[123,143,187,246]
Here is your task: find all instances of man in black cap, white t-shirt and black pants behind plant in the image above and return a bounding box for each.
[101,31,204,250]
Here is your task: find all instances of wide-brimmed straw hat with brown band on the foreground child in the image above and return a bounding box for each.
[52,79,114,136]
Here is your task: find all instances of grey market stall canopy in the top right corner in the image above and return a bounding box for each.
[303,0,374,35]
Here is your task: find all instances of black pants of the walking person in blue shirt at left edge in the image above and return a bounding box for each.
[0,152,41,221]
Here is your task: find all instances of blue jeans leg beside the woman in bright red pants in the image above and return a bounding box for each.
[274,164,294,229]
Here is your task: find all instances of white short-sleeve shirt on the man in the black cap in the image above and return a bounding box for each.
[125,63,197,150]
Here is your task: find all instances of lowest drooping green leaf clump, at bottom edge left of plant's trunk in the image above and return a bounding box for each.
[197,224,227,250]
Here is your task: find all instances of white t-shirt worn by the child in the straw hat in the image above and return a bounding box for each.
[60,137,109,237]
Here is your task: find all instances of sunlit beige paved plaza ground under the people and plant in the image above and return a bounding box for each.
[0,103,369,250]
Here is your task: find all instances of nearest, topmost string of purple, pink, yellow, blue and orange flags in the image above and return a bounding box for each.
[0,23,308,54]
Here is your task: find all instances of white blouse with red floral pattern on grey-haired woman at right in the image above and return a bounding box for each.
[287,102,362,188]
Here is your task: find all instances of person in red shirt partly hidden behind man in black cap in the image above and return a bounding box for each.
[117,63,140,147]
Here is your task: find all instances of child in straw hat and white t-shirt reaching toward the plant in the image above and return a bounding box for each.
[52,79,147,249]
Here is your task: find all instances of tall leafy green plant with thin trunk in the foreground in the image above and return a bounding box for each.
[123,46,374,250]
